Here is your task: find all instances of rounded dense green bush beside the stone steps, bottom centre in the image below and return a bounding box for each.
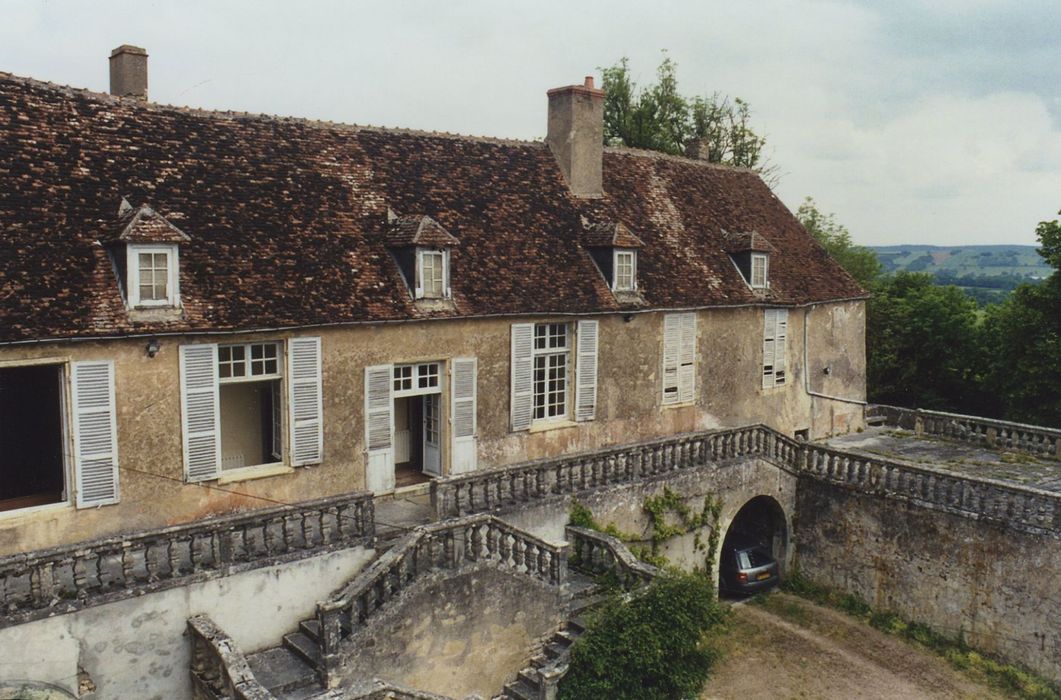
[559,571,724,700]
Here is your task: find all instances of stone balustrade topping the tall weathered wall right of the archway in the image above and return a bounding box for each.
[799,443,1061,533]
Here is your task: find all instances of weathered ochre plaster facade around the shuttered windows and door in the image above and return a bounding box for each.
[0,302,865,556]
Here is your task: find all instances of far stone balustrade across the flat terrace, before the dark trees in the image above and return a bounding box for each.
[866,405,1061,457]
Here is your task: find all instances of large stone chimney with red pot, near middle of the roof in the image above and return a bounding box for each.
[545,75,604,197]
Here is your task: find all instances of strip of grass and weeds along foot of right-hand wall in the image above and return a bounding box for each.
[771,570,1061,700]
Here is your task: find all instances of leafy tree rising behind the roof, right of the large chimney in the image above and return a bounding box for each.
[601,54,777,185]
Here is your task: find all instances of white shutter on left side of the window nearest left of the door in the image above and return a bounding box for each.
[180,345,221,482]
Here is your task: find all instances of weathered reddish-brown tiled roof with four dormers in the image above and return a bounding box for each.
[0,73,863,342]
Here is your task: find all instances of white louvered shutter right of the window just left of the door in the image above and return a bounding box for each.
[288,337,324,467]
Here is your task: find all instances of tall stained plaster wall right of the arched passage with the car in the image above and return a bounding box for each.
[796,479,1061,681]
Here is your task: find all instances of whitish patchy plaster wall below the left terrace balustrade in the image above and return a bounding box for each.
[0,547,372,700]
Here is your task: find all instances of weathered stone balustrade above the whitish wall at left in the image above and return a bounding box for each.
[0,492,376,627]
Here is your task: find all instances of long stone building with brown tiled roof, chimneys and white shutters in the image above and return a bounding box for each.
[0,47,866,555]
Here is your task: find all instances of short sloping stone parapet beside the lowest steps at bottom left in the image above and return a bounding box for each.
[188,615,276,700]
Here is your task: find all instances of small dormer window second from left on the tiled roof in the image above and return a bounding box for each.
[386,212,460,303]
